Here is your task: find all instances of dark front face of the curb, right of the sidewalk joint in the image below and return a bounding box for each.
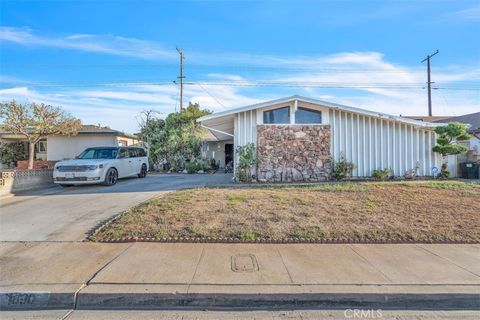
[77,293,480,310]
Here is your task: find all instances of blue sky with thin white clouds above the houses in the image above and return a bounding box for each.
[0,0,480,132]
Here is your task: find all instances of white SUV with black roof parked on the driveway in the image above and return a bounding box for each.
[53,147,148,186]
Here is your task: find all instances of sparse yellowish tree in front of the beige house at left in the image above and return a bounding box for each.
[0,100,81,169]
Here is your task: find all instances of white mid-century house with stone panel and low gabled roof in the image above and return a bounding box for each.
[198,96,441,182]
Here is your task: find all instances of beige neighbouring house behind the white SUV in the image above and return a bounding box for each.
[0,125,139,165]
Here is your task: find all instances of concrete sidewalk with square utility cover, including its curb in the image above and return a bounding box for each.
[0,242,480,310]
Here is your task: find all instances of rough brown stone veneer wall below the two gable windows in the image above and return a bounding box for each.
[257,125,331,182]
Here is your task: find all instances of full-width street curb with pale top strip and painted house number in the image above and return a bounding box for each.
[0,284,480,311]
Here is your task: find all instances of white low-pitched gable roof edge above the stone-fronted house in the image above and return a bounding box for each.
[197,95,441,127]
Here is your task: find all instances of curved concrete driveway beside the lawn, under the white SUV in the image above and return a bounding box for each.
[0,174,232,241]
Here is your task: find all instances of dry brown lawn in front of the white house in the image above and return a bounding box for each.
[93,181,480,241]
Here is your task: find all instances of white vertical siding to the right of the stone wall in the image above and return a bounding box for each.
[329,110,441,177]
